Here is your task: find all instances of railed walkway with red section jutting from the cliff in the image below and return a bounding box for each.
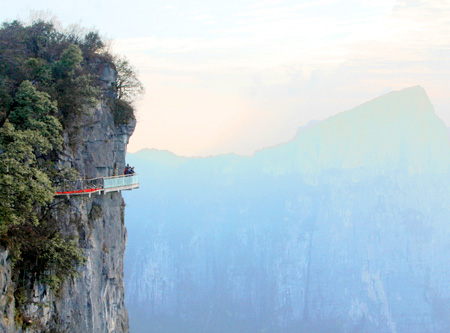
[55,173,139,197]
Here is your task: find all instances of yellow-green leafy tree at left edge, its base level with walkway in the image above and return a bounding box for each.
[0,81,63,231]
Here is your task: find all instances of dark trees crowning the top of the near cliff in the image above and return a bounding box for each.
[0,21,143,127]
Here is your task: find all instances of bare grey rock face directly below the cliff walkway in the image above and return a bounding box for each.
[50,193,128,332]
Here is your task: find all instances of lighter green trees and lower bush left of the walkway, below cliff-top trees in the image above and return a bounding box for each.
[0,81,83,299]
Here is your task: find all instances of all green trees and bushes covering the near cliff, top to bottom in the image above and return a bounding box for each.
[0,17,142,322]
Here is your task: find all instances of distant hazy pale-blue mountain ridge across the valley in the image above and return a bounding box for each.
[125,87,450,332]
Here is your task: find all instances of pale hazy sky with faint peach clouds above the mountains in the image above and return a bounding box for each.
[0,0,450,156]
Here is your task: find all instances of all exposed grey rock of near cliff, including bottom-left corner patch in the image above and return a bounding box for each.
[0,66,135,332]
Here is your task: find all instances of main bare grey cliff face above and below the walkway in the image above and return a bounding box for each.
[47,92,135,332]
